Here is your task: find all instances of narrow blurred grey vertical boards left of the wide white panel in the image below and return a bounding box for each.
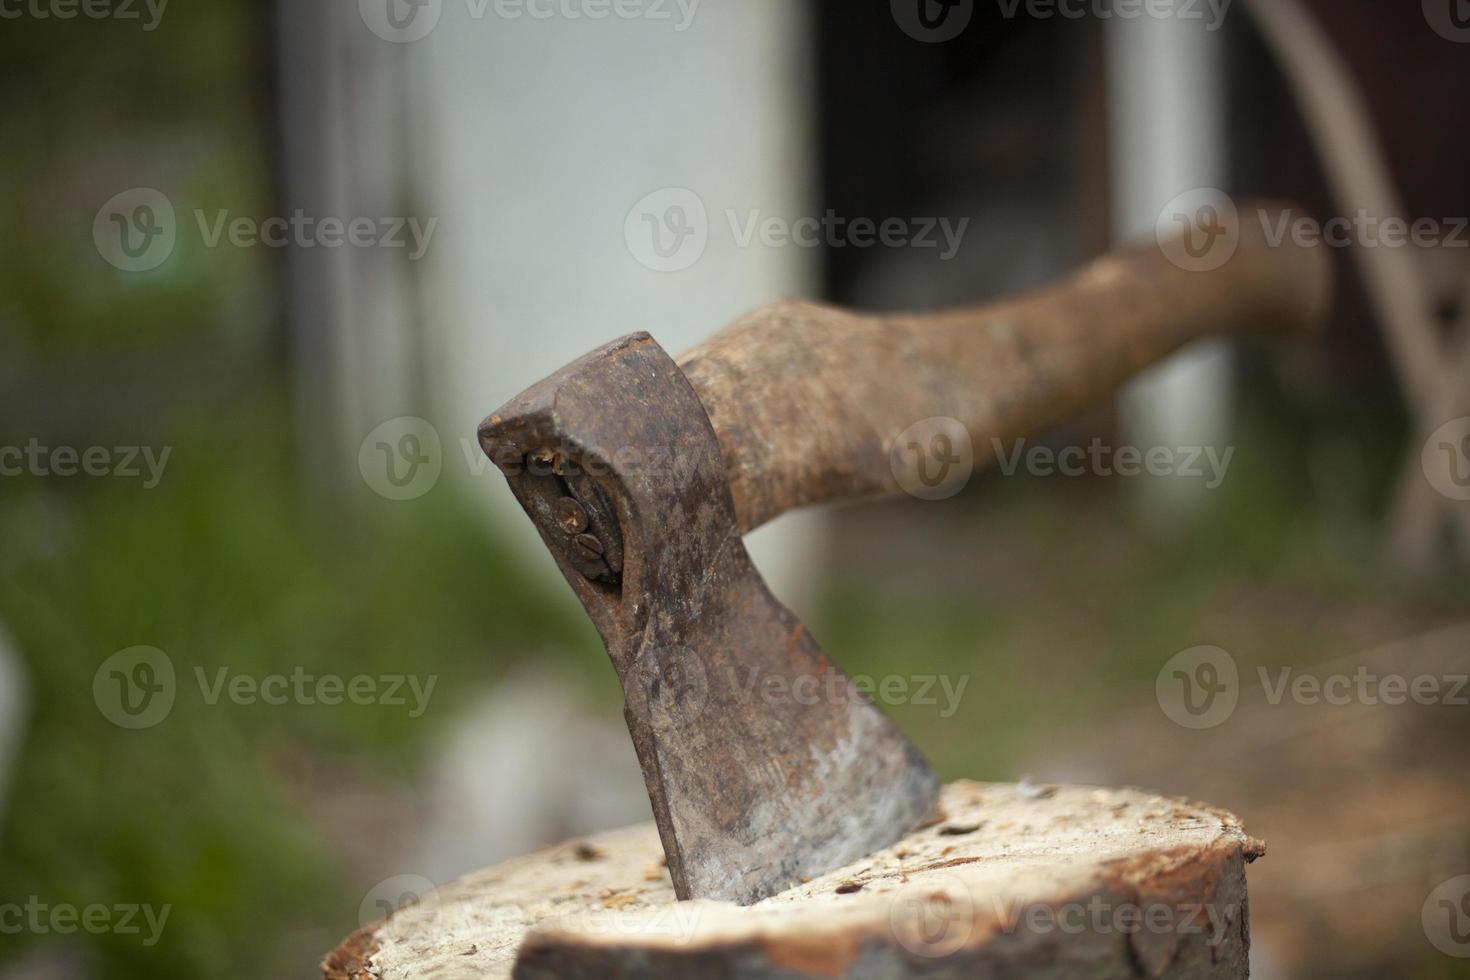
[276,0,420,501]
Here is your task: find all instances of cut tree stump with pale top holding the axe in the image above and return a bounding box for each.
[322,782,1264,980]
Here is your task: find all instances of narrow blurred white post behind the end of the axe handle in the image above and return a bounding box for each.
[1107,7,1230,526]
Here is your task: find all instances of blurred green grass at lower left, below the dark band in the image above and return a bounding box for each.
[0,395,601,977]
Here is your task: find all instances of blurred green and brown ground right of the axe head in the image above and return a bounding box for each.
[823,430,1470,979]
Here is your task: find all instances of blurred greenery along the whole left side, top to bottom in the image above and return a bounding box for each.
[0,7,601,977]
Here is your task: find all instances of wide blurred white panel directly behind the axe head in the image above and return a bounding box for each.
[404,0,820,607]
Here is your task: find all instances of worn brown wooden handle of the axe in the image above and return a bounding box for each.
[679,201,1332,532]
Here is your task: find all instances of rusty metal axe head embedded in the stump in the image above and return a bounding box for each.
[479,334,936,904]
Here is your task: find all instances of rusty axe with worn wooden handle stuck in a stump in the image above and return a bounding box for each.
[479,206,1330,905]
